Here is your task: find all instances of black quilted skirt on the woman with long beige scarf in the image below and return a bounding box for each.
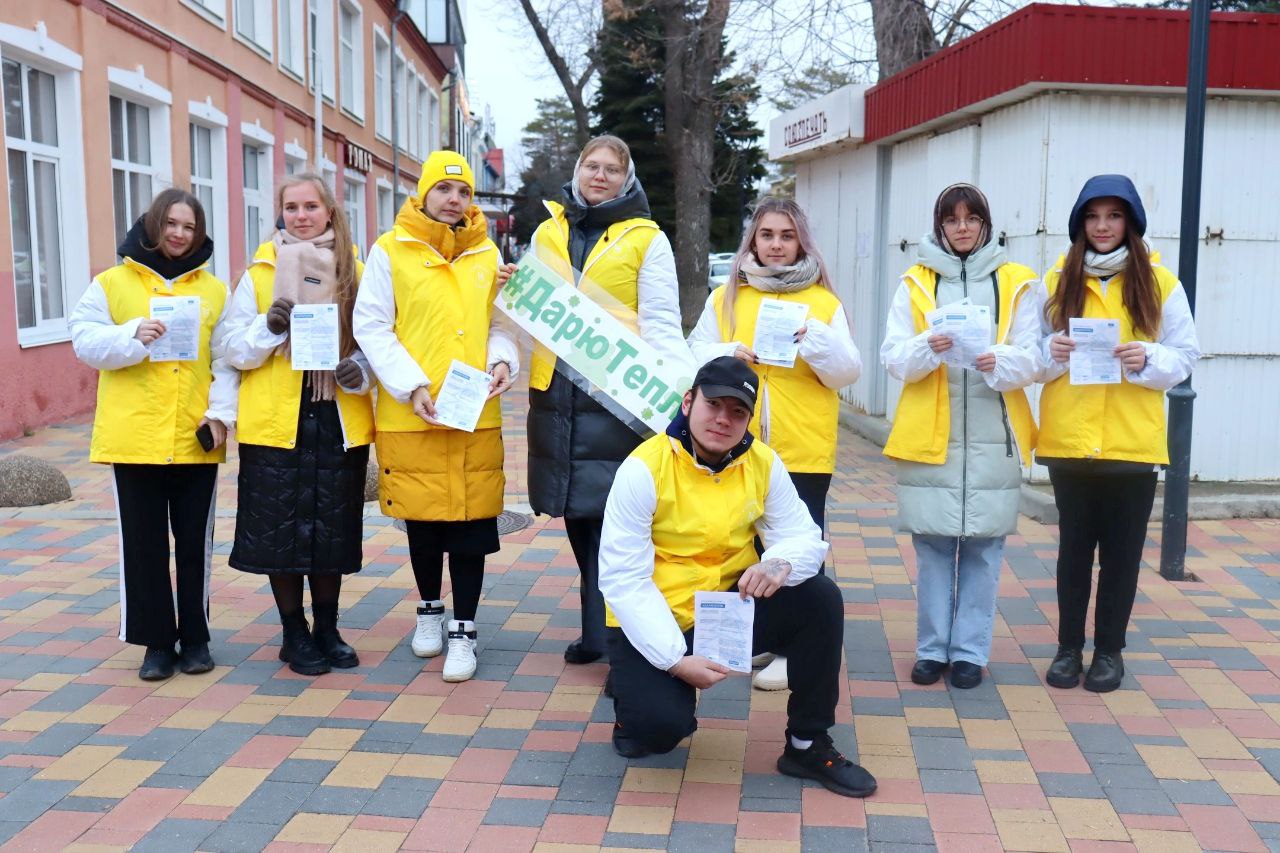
[228,384,369,575]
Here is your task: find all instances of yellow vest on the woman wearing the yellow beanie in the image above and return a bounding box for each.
[375,224,502,433]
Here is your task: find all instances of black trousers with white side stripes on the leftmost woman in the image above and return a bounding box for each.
[111,464,218,648]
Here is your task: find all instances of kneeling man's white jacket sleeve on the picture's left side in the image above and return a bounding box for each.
[600,456,691,671]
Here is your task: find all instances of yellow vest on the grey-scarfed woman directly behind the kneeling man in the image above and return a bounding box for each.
[714,284,840,474]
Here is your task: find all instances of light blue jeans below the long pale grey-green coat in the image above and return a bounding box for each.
[911,534,1005,666]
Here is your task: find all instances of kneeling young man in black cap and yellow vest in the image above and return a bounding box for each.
[600,356,876,797]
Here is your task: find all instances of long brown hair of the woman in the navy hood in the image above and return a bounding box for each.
[1044,205,1160,338]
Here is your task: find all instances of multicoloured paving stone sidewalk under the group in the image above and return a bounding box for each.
[0,394,1280,853]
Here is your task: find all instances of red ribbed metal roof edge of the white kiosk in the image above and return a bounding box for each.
[864,4,1280,142]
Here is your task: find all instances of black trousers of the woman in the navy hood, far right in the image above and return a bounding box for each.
[1048,466,1156,652]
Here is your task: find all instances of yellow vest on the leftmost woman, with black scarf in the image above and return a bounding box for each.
[88,257,227,465]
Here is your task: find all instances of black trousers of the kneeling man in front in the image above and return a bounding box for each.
[608,575,845,753]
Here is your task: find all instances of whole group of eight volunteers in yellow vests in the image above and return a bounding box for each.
[70,119,1198,797]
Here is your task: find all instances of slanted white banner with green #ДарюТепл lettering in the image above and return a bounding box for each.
[494,251,692,433]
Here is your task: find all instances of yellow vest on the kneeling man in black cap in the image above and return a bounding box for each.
[605,433,774,631]
